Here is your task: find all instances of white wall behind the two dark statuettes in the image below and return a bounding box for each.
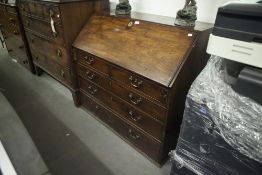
[110,0,258,23]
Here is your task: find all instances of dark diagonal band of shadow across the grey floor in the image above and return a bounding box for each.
[0,56,112,175]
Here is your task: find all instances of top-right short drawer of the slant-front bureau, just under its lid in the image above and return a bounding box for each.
[111,66,168,106]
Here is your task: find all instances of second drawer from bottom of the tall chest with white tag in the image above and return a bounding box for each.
[26,32,70,67]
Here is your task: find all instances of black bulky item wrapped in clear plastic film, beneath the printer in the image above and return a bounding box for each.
[171,56,262,175]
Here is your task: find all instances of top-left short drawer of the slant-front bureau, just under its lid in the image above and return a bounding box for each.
[76,50,110,75]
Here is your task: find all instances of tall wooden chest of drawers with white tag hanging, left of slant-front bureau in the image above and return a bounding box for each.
[19,0,109,102]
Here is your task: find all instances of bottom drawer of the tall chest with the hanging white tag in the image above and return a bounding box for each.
[31,50,73,87]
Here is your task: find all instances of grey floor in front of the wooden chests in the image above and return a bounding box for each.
[0,45,171,175]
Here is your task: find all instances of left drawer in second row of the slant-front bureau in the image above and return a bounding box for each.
[77,64,110,89]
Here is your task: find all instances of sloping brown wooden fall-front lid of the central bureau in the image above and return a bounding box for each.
[73,15,197,87]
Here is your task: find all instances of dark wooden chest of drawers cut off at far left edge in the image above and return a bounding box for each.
[0,0,34,73]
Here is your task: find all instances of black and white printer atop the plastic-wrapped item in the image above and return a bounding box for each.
[207,1,262,104]
